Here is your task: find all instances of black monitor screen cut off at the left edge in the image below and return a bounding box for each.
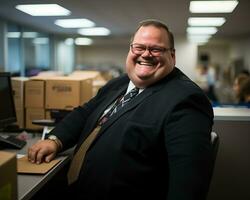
[0,72,17,129]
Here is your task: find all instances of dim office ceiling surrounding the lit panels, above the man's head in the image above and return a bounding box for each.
[0,0,250,41]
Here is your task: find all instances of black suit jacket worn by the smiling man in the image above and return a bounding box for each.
[52,68,213,200]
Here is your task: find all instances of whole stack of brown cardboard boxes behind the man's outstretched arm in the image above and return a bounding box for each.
[12,71,111,130]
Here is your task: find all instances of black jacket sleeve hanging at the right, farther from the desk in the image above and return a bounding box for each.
[165,94,213,200]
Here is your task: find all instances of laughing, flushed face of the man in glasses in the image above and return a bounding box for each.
[126,26,175,88]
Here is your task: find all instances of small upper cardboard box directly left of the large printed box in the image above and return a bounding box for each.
[25,79,45,108]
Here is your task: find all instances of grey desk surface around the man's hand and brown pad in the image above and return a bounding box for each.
[1,134,70,200]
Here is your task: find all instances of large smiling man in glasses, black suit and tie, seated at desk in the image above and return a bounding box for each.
[28,20,213,200]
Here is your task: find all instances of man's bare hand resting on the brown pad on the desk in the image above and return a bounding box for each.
[28,140,59,164]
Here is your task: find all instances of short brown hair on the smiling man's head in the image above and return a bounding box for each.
[130,19,174,50]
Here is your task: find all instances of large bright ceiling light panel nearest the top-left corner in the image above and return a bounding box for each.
[16,4,71,16]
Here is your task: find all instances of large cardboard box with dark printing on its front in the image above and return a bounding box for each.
[45,77,92,110]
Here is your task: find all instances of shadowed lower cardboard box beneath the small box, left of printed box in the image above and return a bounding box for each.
[25,108,45,130]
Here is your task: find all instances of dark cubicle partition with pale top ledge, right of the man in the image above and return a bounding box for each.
[207,108,250,200]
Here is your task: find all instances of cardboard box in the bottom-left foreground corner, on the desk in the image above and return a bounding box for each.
[0,151,17,200]
